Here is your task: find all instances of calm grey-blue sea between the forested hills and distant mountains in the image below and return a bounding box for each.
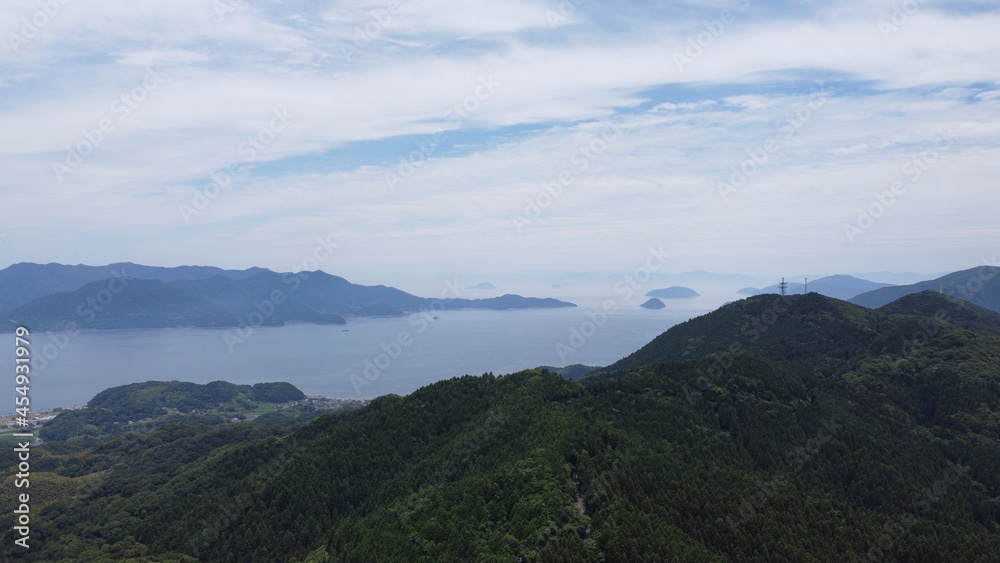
[7,307,707,413]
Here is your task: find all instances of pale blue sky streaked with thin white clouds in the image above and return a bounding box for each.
[0,0,1000,290]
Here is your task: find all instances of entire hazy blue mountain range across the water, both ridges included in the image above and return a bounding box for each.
[0,264,575,330]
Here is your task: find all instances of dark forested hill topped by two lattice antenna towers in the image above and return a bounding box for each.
[591,292,1000,378]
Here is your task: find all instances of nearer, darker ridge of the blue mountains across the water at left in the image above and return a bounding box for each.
[3,270,575,330]
